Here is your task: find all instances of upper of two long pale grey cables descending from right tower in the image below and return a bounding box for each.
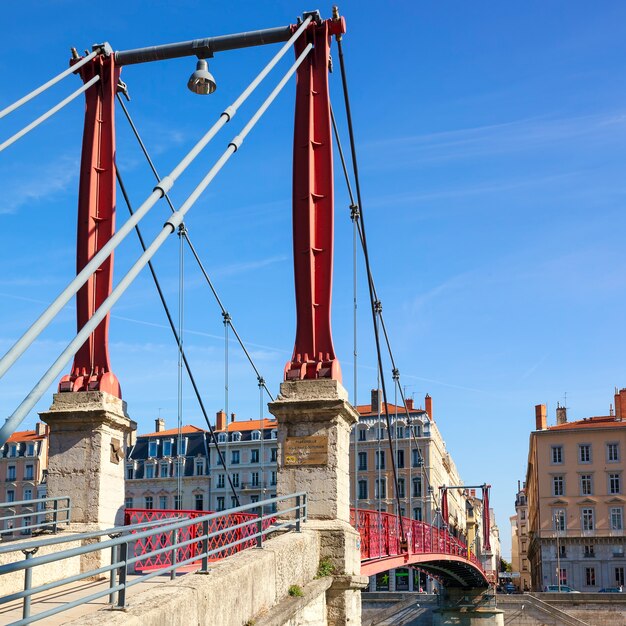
[0,17,311,382]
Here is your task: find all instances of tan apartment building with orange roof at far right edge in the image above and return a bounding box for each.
[526,389,626,591]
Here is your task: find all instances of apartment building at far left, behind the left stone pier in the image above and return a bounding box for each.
[0,422,48,537]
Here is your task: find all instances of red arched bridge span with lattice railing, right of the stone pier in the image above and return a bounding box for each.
[351,510,488,588]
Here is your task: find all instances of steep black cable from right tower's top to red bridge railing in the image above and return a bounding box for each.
[337,38,406,543]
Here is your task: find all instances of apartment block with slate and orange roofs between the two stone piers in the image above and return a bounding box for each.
[125,411,278,511]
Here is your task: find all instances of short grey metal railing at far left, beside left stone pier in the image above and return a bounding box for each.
[0,496,72,536]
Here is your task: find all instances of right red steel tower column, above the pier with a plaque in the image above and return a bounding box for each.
[285,18,345,380]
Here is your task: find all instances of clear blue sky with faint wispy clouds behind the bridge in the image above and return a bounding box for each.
[0,0,626,556]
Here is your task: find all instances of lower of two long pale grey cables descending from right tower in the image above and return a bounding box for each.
[0,44,313,445]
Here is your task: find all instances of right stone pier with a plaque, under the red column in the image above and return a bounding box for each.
[269,379,369,626]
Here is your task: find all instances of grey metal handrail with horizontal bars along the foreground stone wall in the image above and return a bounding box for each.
[0,492,307,626]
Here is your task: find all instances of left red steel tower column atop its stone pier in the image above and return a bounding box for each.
[59,54,122,398]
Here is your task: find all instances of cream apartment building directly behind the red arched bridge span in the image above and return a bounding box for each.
[350,389,466,591]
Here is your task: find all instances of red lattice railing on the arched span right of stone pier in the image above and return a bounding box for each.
[350,509,484,571]
